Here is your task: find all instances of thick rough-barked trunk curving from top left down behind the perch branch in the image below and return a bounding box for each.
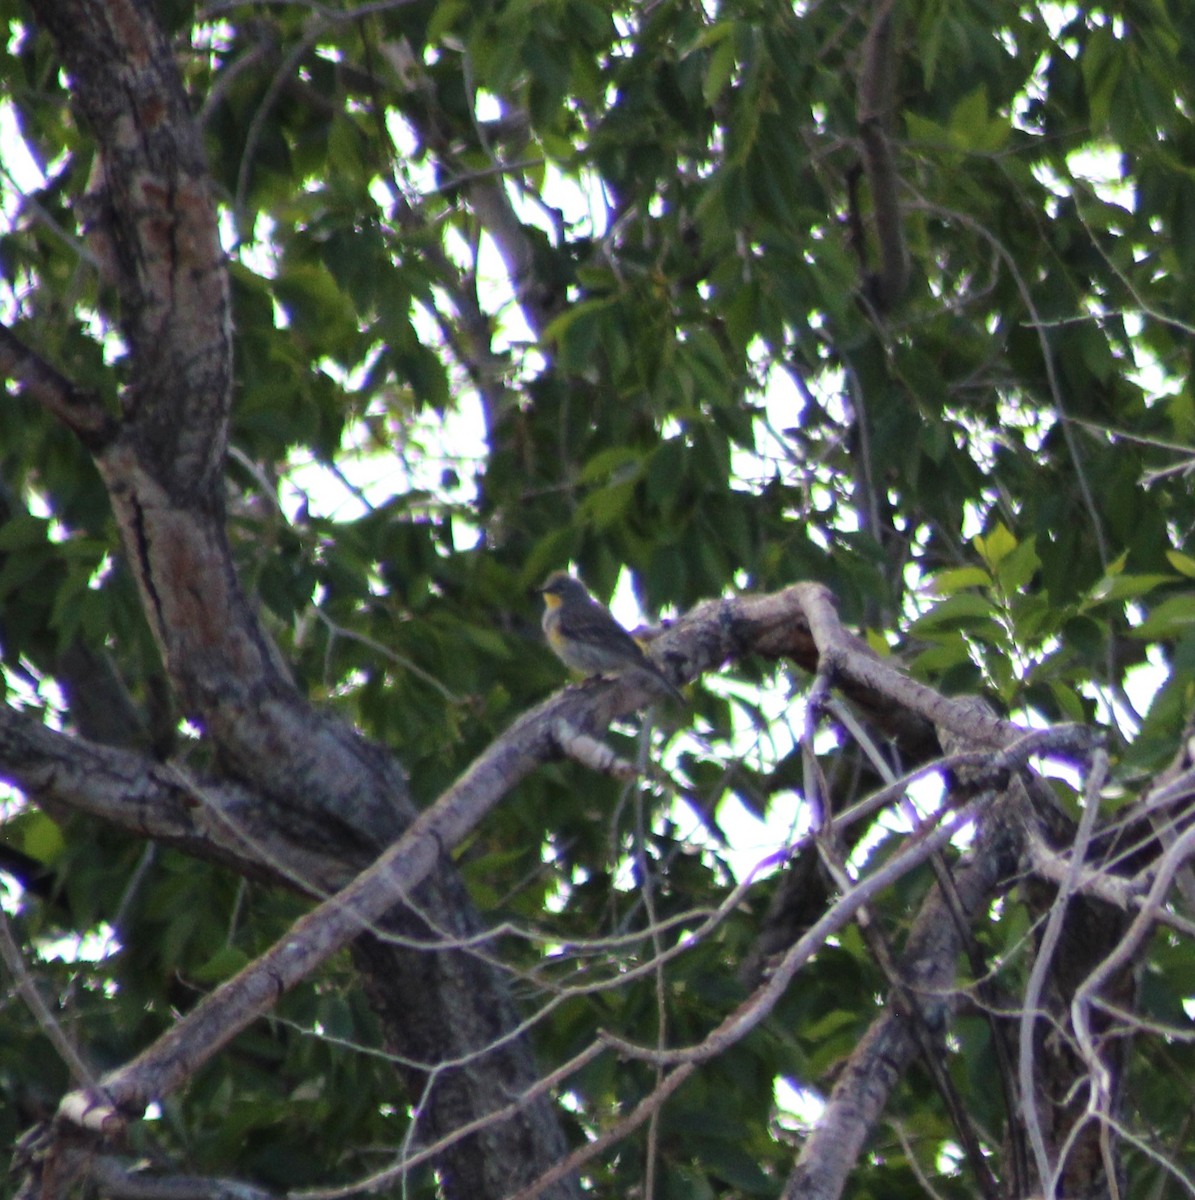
[14,7,572,1198]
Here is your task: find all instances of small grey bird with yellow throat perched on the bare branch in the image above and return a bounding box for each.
[539,571,686,704]
